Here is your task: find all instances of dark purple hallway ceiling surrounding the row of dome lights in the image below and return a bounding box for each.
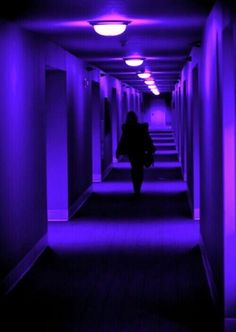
[0,0,215,92]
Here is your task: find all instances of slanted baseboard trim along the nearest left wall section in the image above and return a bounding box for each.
[1,234,48,295]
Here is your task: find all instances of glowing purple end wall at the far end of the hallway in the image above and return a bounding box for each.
[143,93,172,130]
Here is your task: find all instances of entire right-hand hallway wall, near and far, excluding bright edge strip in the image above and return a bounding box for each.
[174,1,223,308]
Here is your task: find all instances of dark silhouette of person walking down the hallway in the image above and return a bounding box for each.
[116,111,155,196]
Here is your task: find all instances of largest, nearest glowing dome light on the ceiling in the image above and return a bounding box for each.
[89,20,130,36]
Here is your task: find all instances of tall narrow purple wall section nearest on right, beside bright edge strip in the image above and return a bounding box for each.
[200,3,224,299]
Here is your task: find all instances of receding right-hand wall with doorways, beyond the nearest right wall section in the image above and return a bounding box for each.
[173,47,201,219]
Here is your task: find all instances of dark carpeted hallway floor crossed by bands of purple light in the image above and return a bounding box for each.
[4,131,219,332]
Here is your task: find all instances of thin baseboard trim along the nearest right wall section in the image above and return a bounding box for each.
[200,236,218,306]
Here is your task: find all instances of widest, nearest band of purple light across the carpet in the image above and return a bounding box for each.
[48,220,199,252]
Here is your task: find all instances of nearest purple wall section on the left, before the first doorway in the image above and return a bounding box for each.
[0,24,47,276]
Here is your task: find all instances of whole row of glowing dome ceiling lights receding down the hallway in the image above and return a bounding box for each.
[89,20,160,95]
